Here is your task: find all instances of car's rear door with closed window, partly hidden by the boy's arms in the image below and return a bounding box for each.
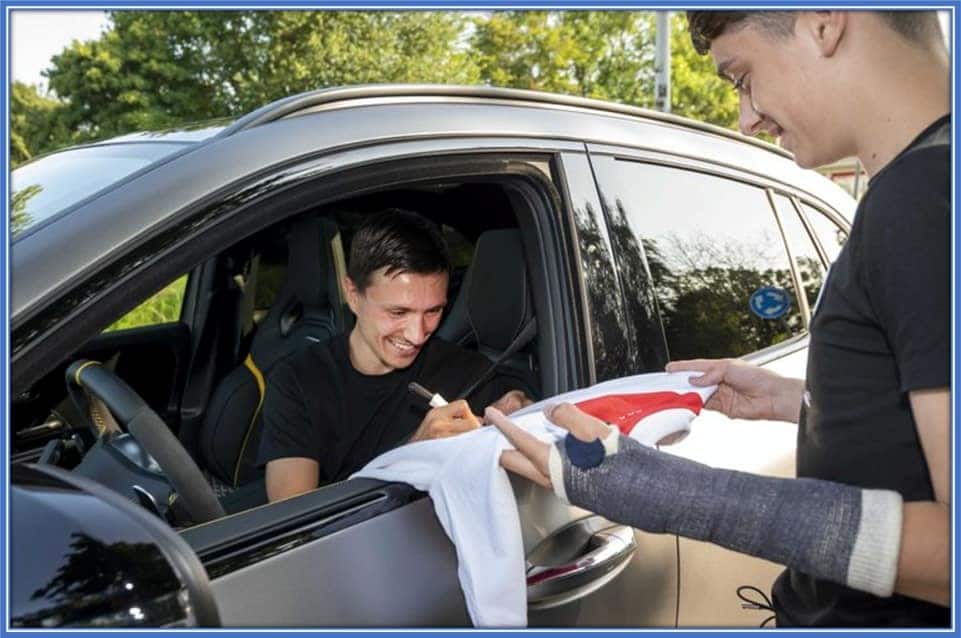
[591,145,852,626]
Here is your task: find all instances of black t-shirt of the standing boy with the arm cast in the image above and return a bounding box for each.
[773,116,951,627]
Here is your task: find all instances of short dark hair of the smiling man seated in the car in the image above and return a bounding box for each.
[347,208,451,292]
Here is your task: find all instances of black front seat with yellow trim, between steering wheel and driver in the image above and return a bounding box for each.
[197,216,344,494]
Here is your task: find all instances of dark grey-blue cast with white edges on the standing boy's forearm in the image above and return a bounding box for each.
[548,428,902,596]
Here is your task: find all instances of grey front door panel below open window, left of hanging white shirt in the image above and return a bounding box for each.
[206,499,470,627]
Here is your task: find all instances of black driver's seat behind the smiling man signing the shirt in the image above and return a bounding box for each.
[436,228,540,396]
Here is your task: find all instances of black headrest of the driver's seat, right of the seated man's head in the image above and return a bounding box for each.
[464,228,534,352]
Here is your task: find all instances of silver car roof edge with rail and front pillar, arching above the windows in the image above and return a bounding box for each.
[11,85,853,324]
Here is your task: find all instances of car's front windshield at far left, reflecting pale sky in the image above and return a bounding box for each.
[10,142,186,240]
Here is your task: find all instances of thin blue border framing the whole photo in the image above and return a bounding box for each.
[0,0,961,636]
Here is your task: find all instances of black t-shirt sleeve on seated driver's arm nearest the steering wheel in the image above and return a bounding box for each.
[258,364,320,465]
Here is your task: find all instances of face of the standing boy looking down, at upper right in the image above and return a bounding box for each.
[711,18,847,168]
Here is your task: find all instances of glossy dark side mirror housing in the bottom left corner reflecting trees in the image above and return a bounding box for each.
[9,464,220,628]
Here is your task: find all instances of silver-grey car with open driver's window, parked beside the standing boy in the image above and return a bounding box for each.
[7,86,854,627]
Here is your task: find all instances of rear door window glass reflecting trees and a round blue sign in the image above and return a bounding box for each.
[602,161,804,359]
